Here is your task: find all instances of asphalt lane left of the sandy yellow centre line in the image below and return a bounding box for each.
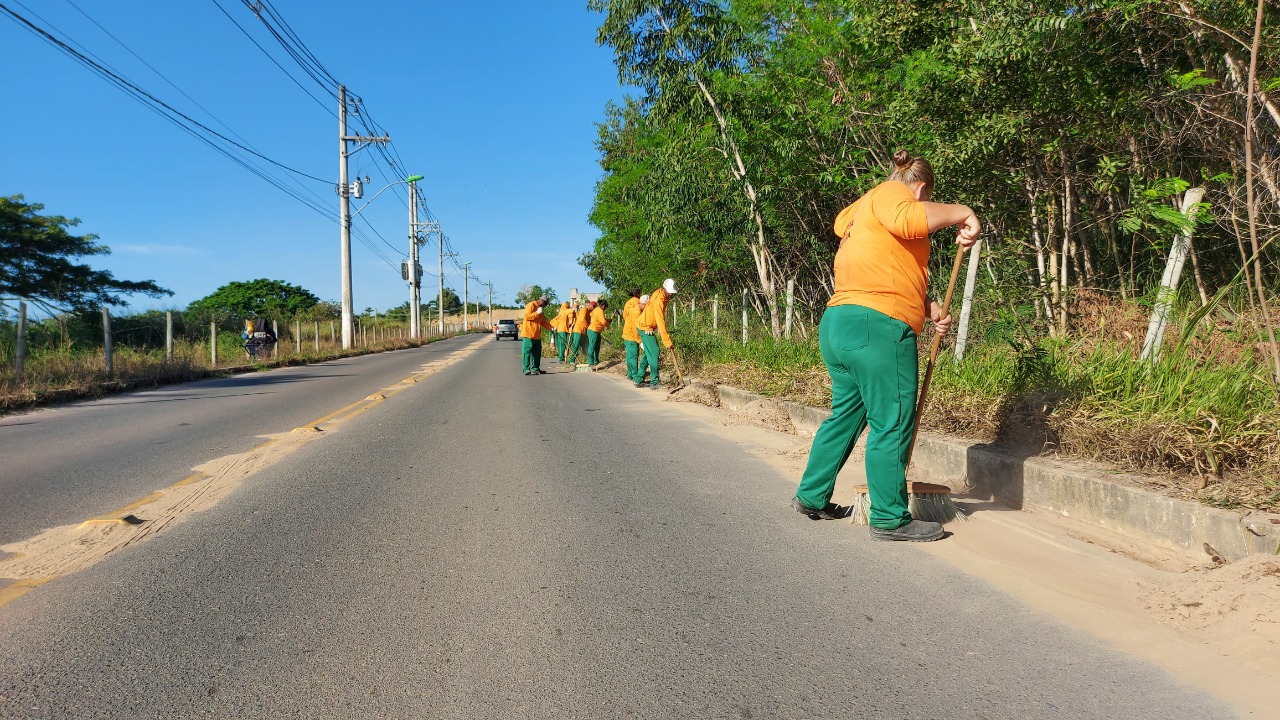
[0,338,483,544]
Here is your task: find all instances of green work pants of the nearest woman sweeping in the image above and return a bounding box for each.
[796,305,919,530]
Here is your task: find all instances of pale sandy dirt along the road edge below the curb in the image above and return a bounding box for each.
[634,368,1280,717]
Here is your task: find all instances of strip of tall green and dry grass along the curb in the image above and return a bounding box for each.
[650,303,1280,510]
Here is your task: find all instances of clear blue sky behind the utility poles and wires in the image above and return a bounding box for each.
[0,0,623,313]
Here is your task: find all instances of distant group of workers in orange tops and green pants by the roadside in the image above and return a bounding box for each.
[520,278,676,389]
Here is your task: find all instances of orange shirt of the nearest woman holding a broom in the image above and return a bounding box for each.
[827,181,929,333]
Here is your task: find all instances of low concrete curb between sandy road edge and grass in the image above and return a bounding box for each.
[714,386,1280,560]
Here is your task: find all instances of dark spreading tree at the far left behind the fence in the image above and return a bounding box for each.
[0,195,173,311]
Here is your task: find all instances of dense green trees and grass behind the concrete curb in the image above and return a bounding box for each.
[580,0,1280,510]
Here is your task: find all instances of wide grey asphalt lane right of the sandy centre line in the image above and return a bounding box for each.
[0,340,1230,720]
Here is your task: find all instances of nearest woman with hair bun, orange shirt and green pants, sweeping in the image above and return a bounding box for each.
[791,150,982,542]
